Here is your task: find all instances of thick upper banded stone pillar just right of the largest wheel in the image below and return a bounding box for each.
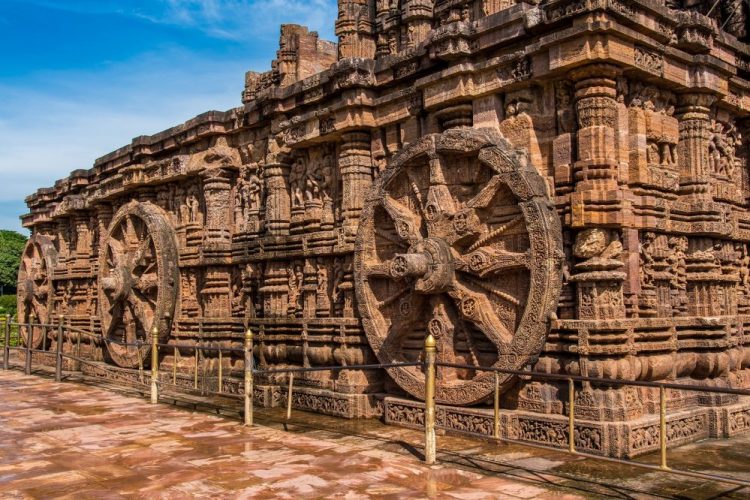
[570,64,619,192]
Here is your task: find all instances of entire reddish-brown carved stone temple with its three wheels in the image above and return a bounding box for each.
[19,0,750,456]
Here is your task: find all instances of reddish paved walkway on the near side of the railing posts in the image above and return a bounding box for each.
[0,371,573,499]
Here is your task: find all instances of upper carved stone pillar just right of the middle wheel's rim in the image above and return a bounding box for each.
[203,168,232,243]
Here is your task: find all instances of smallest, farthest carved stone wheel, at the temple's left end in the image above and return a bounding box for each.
[16,234,57,349]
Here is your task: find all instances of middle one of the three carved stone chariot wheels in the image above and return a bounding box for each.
[99,201,179,368]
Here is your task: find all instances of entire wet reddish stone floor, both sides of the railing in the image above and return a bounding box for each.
[0,371,750,499]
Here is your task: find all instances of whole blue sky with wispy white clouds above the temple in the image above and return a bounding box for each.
[0,0,337,234]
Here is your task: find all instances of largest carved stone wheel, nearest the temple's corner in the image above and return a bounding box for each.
[354,129,563,405]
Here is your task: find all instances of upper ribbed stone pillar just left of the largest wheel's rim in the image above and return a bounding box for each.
[339,131,372,230]
